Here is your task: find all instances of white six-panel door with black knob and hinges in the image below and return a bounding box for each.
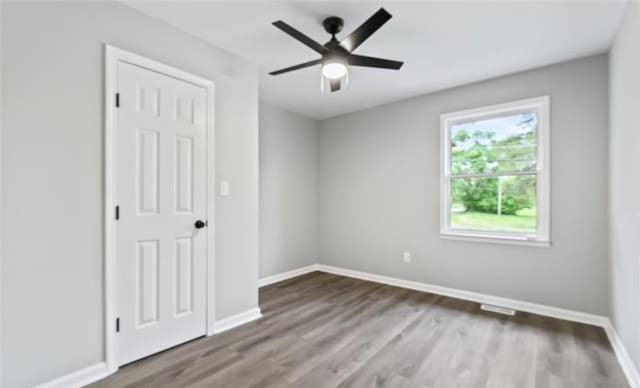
[116,62,207,365]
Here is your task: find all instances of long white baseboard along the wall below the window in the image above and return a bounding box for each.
[318,264,608,327]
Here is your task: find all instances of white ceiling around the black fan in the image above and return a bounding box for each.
[127,0,625,119]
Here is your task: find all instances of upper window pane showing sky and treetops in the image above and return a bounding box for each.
[449,112,538,175]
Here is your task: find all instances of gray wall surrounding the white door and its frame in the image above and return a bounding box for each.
[1,2,258,387]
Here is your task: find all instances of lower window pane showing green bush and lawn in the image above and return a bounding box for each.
[449,175,536,233]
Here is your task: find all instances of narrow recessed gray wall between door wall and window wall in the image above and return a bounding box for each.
[259,102,318,278]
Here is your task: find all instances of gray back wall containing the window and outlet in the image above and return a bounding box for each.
[319,55,608,314]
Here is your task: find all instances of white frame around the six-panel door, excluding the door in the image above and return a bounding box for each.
[104,44,216,373]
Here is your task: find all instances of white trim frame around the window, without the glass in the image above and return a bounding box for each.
[440,96,551,247]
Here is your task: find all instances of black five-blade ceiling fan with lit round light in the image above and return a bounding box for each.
[269,8,403,92]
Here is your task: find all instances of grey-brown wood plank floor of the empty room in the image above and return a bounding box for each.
[92,272,628,388]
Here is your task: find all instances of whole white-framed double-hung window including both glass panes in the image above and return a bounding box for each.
[440,97,550,246]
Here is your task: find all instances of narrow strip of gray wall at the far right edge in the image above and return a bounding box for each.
[609,1,640,368]
